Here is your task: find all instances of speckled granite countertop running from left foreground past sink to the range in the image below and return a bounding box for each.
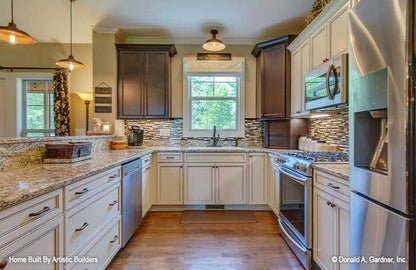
[0,147,294,211]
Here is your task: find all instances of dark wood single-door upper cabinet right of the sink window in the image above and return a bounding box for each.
[251,35,296,120]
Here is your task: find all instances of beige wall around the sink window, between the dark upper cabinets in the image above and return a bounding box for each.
[172,44,256,118]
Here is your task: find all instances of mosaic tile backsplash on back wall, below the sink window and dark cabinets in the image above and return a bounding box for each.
[125,118,264,147]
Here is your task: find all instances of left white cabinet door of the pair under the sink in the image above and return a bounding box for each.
[184,163,215,204]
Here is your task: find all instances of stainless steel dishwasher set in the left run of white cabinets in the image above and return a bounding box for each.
[122,159,142,247]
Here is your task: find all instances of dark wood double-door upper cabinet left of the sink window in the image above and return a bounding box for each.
[116,44,176,119]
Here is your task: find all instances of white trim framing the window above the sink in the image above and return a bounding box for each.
[183,57,245,138]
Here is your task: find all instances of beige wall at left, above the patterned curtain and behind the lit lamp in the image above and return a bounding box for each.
[0,43,93,134]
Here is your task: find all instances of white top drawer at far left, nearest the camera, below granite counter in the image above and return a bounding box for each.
[0,189,62,243]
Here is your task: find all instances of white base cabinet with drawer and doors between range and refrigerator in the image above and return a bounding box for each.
[313,171,349,270]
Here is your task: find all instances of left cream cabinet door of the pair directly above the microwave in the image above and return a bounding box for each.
[310,24,328,69]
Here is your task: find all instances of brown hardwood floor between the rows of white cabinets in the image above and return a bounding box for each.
[107,212,303,270]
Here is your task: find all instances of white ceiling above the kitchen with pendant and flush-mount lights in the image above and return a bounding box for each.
[0,0,314,44]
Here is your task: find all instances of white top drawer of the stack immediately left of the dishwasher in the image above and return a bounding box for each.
[65,167,121,209]
